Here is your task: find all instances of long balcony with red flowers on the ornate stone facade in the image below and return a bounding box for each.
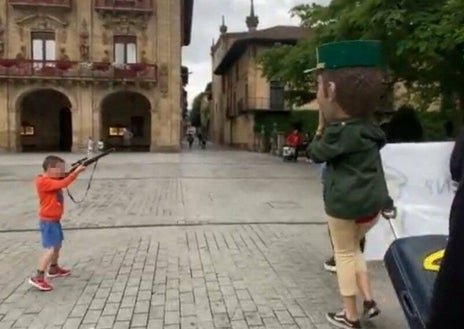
[0,59,158,85]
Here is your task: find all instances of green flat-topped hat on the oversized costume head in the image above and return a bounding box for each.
[304,40,386,73]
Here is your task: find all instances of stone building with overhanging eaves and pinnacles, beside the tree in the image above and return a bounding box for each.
[209,1,310,150]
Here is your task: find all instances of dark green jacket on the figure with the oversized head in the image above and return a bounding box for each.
[308,119,393,220]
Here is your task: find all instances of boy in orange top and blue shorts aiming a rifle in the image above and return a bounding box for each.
[29,155,85,291]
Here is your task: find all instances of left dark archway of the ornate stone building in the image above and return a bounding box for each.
[19,89,72,152]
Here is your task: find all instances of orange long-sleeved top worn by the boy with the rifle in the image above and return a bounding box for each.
[35,172,77,222]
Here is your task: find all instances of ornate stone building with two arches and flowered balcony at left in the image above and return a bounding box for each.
[0,0,193,152]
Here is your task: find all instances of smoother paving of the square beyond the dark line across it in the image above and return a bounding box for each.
[0,151,324,230]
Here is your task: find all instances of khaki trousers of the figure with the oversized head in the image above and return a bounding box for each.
[328,216,379,297]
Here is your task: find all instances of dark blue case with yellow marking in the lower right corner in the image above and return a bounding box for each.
[384,235,448,329]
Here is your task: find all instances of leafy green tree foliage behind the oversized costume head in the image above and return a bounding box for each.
[260,0,464,108]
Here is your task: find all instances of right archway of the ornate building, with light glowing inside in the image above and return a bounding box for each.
[100,91,151,152]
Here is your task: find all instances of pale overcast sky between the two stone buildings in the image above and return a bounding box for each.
[183,0,330,107]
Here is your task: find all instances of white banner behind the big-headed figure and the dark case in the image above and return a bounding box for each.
[365,142,454,260]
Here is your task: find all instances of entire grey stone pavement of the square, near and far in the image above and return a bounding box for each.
[0,151,406,329]
